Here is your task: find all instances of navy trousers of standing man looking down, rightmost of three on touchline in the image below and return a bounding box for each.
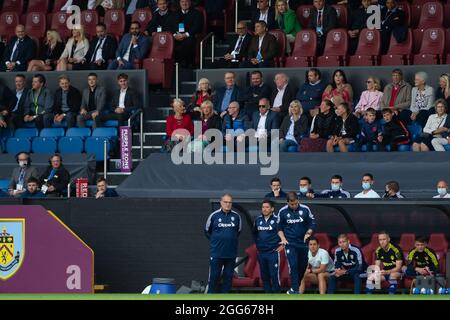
[285,245,308,292]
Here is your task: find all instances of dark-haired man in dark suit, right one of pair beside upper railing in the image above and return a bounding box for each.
[242,21,278,68]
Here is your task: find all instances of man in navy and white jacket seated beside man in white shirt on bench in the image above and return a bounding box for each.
[327,233,365,294]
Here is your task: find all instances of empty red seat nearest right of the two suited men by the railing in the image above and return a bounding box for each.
[286,30,317,68]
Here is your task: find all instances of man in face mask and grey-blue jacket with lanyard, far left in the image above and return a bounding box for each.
[8,152,39,197]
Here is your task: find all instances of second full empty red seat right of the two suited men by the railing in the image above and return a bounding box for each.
[317,29,348,67]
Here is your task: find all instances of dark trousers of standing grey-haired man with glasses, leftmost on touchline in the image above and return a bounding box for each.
[208,257,236,293]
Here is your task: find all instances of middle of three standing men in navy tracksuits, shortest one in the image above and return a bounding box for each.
[253,200,283,293]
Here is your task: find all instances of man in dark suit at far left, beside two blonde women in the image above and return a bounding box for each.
[0,24,36,71]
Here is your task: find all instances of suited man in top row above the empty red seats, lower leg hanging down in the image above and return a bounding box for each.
[308,0,337,55]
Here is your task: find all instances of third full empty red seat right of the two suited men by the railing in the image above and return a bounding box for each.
[349,29,381,66]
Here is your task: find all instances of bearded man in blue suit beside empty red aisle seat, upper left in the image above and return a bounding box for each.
[108,21,150,70]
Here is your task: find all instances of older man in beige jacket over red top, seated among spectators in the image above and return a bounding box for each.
[381,69,411,116]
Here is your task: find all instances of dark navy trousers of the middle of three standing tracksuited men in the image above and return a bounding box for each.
[258,251,281,293]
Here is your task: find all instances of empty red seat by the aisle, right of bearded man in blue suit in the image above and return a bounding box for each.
[143,32,174,89]
